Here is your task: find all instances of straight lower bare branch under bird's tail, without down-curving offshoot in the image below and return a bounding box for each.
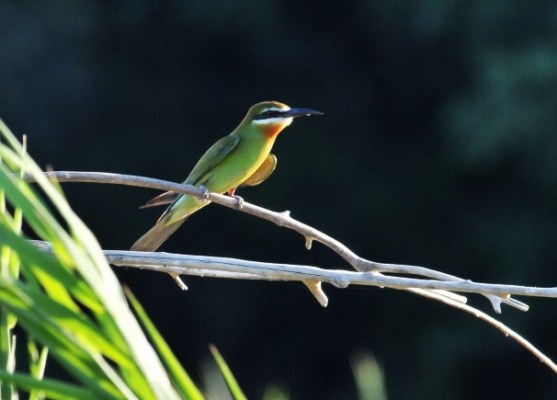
[32,240,557,303]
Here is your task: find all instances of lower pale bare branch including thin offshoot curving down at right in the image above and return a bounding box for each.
[29,241,557,373]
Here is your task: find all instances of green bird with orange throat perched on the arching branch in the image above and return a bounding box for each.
[131,101,323,289]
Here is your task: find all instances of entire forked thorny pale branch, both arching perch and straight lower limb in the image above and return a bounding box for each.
[27,171,557,373]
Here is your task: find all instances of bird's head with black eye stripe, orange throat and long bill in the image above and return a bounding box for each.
[242,101,323,137]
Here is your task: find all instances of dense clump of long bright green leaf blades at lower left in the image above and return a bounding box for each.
[0,120,201,399]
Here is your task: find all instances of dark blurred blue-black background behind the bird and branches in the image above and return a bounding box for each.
[0,0,557,399]
